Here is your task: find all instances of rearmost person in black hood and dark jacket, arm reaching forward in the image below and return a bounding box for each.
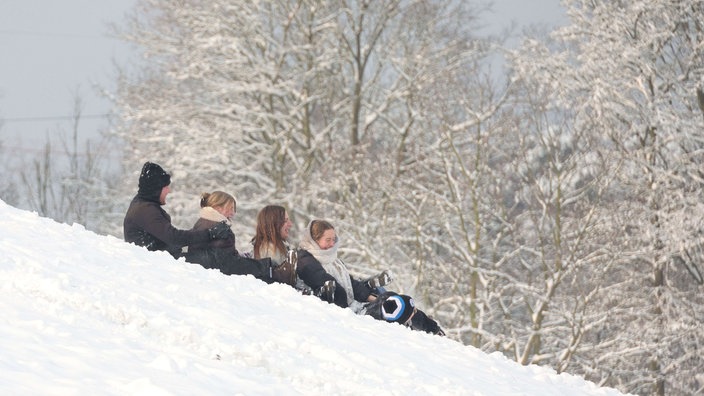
[123,162,232,258]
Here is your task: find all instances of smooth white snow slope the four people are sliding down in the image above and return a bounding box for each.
[0,201,621,396]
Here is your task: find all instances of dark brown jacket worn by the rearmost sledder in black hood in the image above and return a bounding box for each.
[123,194,210,257]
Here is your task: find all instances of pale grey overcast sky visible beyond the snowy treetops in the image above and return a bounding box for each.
[0,0,565,152]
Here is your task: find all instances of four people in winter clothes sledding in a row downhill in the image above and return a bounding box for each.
[123,162,445,335]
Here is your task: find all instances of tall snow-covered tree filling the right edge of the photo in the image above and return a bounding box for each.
[517,0,704,395]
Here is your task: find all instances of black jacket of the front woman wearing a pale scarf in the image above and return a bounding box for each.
[296,249,372,308]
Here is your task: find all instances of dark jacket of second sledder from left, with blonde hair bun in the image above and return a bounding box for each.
[186,213,274,283]
